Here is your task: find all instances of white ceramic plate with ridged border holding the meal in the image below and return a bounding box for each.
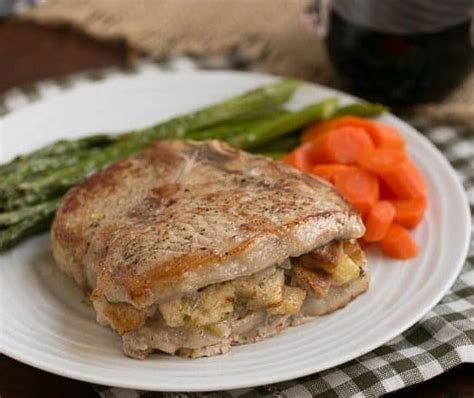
[0,70,470,391]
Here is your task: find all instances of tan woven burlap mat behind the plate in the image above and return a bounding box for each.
[20,0,474,122]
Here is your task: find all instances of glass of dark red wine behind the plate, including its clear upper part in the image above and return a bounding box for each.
[312,0,474,106]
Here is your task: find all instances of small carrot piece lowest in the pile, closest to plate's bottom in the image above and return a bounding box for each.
[381,223,419,260]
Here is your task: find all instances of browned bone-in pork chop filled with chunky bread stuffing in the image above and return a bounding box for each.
[52,140,369,358]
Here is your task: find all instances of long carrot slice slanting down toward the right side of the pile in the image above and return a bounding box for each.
[357,148,426,199]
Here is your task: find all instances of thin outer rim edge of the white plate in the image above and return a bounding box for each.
[0,70,472,392]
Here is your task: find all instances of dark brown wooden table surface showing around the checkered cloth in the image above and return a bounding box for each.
[0,17,474,398]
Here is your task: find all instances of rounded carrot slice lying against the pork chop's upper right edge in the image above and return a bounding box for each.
[334,168,379,215]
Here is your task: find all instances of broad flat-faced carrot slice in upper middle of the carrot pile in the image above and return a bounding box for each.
[312,126,374,164]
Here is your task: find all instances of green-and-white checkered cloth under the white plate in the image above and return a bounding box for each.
[0,59,474,398]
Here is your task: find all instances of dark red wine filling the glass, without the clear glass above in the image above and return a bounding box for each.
[320,3,474,105]
